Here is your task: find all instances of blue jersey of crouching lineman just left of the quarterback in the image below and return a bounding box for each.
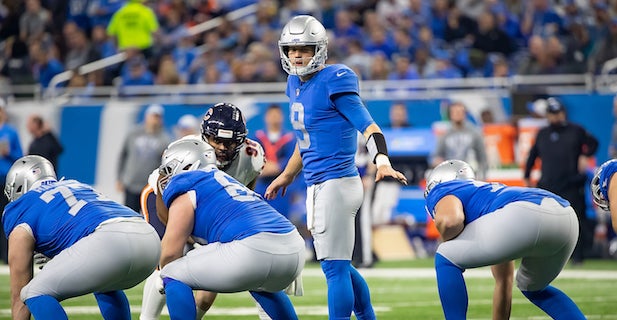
[163,166,295,243]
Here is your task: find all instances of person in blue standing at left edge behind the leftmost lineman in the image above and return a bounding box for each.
[0,98,23,263]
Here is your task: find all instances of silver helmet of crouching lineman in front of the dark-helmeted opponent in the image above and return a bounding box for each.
[158,138,216,191]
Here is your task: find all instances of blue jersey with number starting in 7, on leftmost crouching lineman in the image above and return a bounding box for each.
[2,180,141,258]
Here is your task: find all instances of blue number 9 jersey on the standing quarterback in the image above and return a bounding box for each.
[286,64,373,186]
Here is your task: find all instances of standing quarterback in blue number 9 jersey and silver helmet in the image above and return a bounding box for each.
[265,15,407,319]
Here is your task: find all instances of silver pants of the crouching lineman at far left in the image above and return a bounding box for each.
[21,218,160,319]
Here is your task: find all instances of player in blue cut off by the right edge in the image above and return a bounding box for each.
[591,159,617,232]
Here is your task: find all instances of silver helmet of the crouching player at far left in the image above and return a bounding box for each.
[4,155,58,202]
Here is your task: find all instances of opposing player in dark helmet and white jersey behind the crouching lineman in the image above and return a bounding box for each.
[140,102,269,320]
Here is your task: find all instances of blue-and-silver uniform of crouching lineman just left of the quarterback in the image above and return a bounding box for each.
[161,165,304,319]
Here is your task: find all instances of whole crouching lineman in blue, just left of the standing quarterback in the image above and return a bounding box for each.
[157,140,305,320]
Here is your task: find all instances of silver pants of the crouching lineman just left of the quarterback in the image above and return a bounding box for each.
[161,232,304,314]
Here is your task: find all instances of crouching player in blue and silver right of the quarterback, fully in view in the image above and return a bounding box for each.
[424,160,585,320]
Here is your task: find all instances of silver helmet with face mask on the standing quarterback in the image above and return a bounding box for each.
[279,15,328,76]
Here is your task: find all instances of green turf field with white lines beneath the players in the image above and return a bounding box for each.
[0,259,617,320]
